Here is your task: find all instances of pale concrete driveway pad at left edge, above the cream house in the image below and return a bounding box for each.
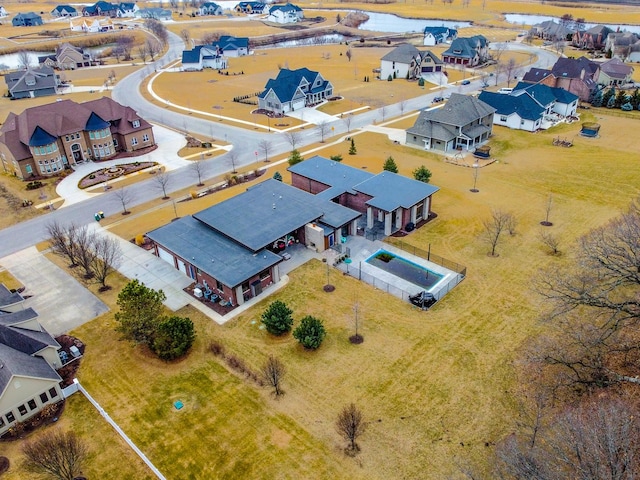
[0,247,109,336]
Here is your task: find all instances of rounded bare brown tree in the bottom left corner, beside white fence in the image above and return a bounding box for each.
[22,430,88,480]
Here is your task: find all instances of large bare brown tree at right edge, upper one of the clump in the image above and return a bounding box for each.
[533,198,640,390]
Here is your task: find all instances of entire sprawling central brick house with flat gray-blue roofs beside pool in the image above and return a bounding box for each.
[147,156,438,305]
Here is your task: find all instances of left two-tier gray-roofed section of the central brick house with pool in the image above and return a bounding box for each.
[147,179,360,305]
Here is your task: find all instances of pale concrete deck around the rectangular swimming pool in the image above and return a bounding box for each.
[339,237,458,298]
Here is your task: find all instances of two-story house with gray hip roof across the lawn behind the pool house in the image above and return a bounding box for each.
[406,93,496,152]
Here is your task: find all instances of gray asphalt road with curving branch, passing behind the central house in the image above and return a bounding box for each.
[0,33,557,258]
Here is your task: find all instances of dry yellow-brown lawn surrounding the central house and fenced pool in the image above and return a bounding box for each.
[38,113,640,479]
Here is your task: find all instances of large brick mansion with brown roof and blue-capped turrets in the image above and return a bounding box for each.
[0,97,155,179]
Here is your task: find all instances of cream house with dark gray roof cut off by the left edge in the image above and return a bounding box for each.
[0,285,63,435]
